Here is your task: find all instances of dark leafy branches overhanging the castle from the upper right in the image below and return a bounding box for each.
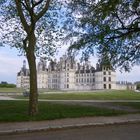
[67,0,140,70]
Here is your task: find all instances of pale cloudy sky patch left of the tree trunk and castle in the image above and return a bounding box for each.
[0,48,24,83]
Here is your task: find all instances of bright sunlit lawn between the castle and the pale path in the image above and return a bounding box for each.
[15,90,140,100]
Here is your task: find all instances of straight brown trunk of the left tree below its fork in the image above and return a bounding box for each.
[26,33,38,116]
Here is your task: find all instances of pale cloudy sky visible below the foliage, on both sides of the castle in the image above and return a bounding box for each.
[0,47,140,84]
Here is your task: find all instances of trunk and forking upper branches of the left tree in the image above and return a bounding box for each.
[14,0,51,116]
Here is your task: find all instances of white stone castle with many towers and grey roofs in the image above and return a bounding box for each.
[17,55,116,90]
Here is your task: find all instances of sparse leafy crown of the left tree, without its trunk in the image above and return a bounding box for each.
[0,0,62,57]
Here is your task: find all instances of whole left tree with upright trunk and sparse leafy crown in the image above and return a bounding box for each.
[0,0,64,116]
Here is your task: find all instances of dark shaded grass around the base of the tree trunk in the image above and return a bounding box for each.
[0,101,127,122]
